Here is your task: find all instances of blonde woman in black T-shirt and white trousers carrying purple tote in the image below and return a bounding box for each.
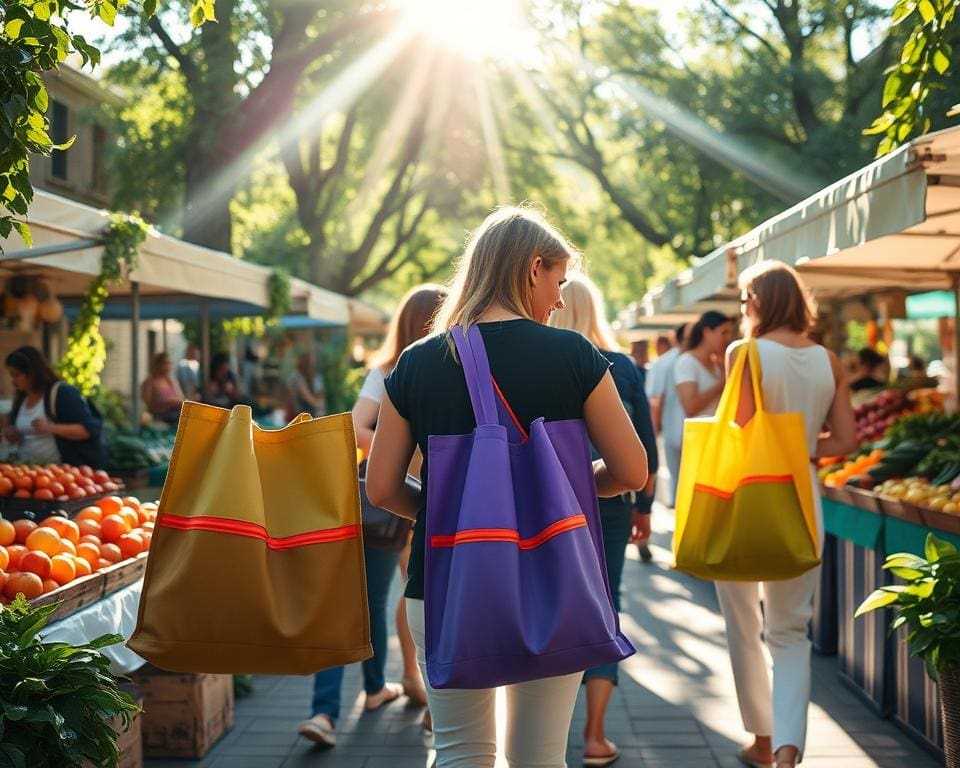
[367,208,647,768]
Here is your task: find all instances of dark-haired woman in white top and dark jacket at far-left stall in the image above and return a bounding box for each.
[3,346,105,468]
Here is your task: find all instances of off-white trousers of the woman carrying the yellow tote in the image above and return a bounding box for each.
[717,566,820,757]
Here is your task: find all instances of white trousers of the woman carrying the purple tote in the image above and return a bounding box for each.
[407,599,583,768]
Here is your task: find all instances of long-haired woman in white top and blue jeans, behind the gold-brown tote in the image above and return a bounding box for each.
[298,285,446,747]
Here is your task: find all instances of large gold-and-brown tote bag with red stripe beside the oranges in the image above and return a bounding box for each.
[128,402,373,675]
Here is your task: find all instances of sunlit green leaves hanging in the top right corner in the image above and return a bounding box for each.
[863,0,960,157]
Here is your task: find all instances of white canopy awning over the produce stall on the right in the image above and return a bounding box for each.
[644,128,960,315]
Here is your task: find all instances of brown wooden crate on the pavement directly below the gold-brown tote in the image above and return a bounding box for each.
[133,665,233,759]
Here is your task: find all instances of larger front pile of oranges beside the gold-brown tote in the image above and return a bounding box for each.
[0,496,157,605]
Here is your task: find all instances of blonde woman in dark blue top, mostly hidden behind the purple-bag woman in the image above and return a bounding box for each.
[550,274,657,768]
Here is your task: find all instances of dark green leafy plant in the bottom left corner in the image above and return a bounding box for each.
[0,595,137,768]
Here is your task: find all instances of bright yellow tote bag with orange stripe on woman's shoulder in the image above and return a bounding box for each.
[673,340,820,581]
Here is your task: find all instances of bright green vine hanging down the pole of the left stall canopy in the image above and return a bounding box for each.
[57,213,149,395]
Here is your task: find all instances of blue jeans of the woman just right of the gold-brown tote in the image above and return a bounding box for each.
[310,547,400,721]
